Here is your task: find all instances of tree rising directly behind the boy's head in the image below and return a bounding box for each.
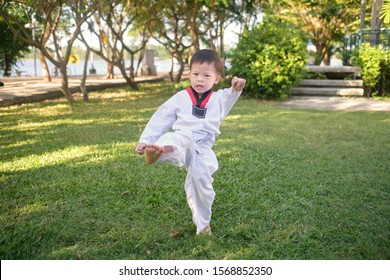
[145,0,245,81]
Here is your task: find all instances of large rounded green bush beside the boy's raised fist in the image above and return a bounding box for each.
[230,17,307,98]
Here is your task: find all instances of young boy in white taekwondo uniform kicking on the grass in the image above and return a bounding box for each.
[136,49,246,234]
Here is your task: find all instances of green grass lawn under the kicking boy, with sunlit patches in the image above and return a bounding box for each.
[0,83,390,260]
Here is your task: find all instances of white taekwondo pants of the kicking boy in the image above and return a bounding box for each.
[156,130,218,234]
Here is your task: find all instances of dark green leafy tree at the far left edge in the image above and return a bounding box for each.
[0,18,29,76]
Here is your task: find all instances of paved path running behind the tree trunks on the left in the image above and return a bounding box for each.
[0,75,165,107]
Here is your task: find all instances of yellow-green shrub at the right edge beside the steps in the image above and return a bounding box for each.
[353,45,390,96]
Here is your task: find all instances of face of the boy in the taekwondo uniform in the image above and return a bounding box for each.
[190,63,221,95]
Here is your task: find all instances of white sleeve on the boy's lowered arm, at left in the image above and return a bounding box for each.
[139,96,176,144]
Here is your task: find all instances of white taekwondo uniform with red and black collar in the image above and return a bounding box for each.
[139,88,241,234]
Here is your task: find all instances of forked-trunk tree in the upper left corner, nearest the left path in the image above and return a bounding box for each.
[0,0,104,104]
